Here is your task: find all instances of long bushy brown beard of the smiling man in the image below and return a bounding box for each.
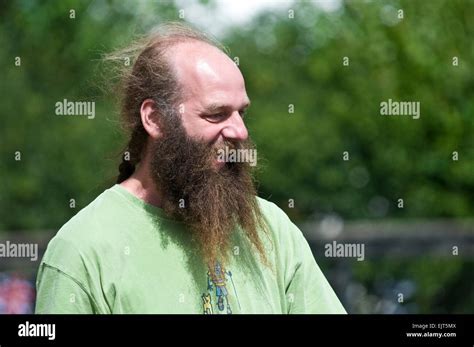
[150,116,267,265]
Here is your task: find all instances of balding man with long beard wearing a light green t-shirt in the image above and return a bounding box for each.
[36,24,345,314]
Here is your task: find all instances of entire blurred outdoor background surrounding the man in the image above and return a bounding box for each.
[0,0,474,314]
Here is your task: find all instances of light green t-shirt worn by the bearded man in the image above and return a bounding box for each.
[36,185,345,314]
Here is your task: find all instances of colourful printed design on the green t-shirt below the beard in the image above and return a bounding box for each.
[201,261,240,314]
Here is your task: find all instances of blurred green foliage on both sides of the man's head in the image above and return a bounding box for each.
[0,0,474,229]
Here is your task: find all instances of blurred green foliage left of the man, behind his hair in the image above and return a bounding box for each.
[0,1,179,230]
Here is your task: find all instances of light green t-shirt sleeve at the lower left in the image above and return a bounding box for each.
[35,263,96,314]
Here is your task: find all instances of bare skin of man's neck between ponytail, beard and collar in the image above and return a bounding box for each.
[120,160,162,207]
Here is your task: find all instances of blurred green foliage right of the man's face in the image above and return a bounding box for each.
[229,0,474,222]
